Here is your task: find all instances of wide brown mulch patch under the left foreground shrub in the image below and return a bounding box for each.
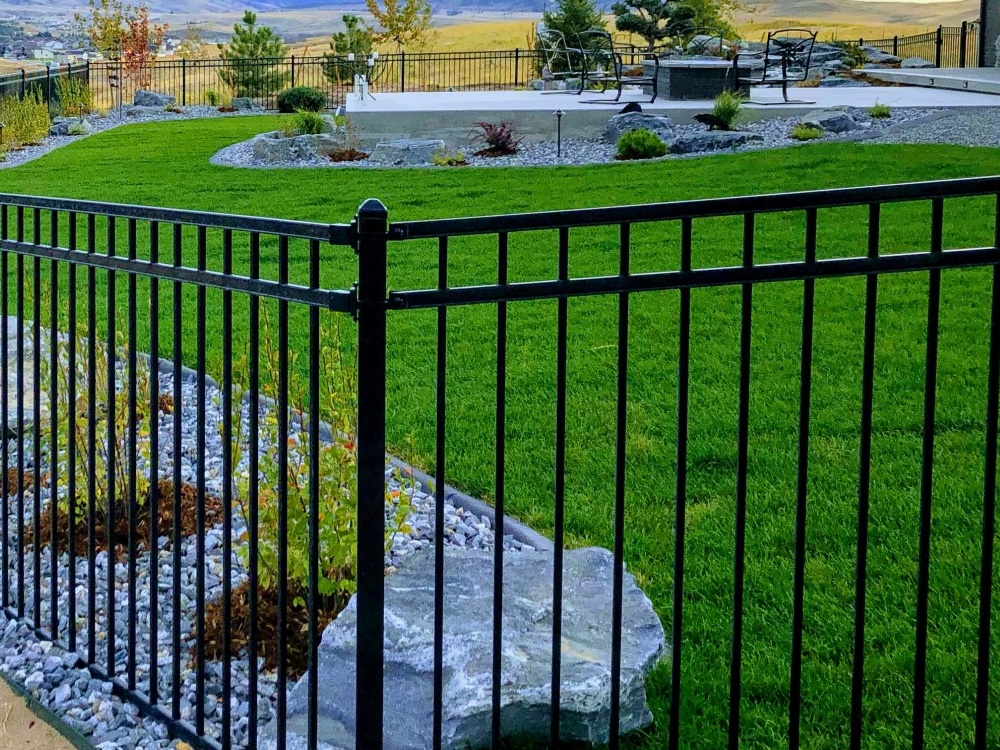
[23,479,222,557]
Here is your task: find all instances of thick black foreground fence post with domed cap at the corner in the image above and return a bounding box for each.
[354,199,389,750]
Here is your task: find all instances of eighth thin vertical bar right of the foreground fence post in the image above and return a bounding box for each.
[851,203,881,750]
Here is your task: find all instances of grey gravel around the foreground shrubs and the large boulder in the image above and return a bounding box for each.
[0,362,530,750]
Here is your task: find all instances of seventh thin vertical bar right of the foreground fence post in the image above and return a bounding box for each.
[788,208,816,750]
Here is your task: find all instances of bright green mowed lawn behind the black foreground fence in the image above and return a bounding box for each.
[0,118,1000,750]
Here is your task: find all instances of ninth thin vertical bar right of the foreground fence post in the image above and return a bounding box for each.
[913,198,944,750]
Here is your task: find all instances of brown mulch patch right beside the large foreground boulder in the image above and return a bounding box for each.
[205,583,350,679]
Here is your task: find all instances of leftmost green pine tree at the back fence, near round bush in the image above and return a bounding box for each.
[219,10,290,96]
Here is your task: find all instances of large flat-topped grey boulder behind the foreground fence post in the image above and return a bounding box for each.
[270,548,664,750]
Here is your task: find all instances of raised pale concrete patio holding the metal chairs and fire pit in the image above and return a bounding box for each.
[346,86,1000,144]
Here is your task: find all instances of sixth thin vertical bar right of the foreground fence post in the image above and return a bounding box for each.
[729,214,755,750]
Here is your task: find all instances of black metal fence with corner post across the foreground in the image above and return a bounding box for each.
[0,178,1000,750]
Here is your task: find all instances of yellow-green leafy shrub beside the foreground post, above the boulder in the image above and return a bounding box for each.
[233,308,410,606]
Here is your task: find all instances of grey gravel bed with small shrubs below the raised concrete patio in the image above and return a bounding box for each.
[210,109,937,169]
